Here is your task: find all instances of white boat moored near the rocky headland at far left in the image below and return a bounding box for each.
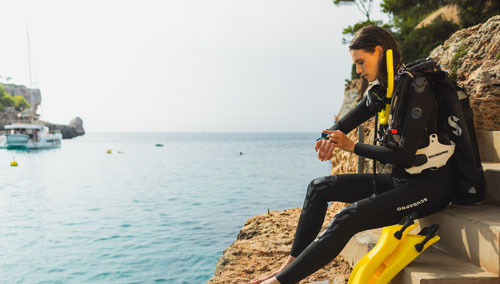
[4,123,62,149]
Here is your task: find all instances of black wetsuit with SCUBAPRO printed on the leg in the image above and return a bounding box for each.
[276,77,452,284]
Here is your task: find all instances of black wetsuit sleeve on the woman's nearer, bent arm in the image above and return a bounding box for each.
[354,77,435,168]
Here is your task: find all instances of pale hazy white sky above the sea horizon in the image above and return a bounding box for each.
[0,0,388,133]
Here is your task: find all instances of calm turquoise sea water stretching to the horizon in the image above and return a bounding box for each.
[0,133,330,284]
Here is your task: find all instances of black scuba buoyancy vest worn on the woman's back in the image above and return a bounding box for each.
[378,58,485,205]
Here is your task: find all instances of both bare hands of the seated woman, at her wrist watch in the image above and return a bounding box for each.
[315,130,355,161]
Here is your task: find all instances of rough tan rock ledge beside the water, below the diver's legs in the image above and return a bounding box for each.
[207,203,351,284]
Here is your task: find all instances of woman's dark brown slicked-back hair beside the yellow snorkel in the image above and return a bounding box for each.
[349,25,401,87]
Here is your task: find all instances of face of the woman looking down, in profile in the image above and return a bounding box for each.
[350,45,383,82]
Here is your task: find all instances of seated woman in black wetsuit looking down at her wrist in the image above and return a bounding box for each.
[252,26,452,284]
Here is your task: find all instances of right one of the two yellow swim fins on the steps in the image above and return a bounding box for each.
[367,224,440,284]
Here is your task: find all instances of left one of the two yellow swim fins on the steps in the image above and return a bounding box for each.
[348,212,418,284]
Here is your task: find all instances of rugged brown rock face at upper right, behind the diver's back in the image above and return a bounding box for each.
[430,15,500,131]
